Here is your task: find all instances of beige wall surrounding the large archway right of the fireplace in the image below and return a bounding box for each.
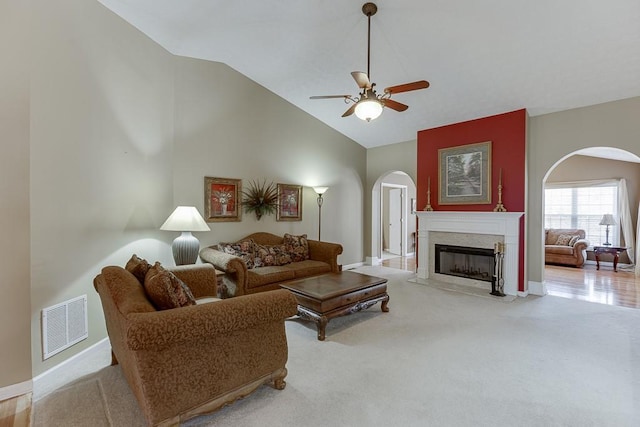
[527,97,640,283]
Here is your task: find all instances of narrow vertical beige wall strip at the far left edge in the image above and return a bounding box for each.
[0,0,31,388]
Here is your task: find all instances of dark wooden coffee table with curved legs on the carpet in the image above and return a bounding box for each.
[280,271,389,341]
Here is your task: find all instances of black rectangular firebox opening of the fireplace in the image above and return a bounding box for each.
[434,244,495,283]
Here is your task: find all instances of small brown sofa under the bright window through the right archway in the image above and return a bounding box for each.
[544,228,589,267]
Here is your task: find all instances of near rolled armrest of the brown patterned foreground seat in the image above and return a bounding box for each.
[126,289,298,351]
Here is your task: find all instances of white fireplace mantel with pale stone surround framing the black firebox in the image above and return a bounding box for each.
[416,211,523,296]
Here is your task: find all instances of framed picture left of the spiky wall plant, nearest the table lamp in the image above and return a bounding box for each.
[204,176,242,222]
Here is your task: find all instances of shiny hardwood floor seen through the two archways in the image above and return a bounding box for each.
[382,256,640,308]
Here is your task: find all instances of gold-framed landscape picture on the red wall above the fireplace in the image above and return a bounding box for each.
[438,141,491,205]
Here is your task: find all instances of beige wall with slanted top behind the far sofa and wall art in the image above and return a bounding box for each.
[173,58,366,264]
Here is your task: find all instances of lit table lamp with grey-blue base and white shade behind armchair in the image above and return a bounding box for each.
[160,206,211,265]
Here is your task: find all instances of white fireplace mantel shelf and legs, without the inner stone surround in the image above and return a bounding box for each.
[416,211,524,296]
